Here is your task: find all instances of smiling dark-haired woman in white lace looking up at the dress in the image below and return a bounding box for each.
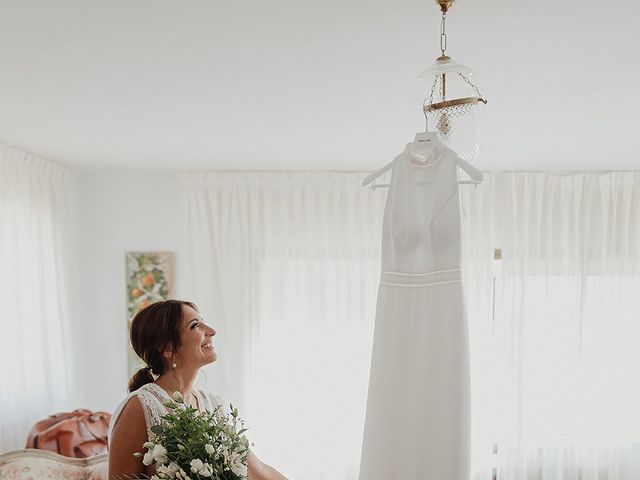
[109,300,286,480]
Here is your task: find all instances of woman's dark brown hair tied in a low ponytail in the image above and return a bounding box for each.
[129,300,198,392]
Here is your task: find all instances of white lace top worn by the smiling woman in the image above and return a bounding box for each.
[108,383,222,446]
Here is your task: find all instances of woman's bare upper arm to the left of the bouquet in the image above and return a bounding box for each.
[107,396,147,480]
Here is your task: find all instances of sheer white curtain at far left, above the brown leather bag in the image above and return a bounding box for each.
[0,145,72,452]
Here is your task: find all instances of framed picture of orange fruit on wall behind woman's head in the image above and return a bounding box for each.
[125,252,173,377]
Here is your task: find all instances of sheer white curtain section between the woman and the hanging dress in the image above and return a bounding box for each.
[186,172,384,480]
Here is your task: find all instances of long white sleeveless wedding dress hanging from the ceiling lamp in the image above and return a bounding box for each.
[360,141,470,480]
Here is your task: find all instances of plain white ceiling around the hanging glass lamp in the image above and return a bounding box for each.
[0,0,640,171]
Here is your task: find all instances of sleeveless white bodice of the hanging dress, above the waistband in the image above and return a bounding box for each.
[382,140,460,274]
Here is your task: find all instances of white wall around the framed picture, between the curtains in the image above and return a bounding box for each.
[69,172,187,411]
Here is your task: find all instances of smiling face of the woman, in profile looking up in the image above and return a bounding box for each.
[177,305,218,367]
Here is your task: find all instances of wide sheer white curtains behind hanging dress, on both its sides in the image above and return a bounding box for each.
[182,172,640,480]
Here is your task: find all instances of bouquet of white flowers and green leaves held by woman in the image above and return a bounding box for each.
[134,392,249,480]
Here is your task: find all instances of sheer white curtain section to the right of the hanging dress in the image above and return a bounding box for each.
[463,172,640,480]
